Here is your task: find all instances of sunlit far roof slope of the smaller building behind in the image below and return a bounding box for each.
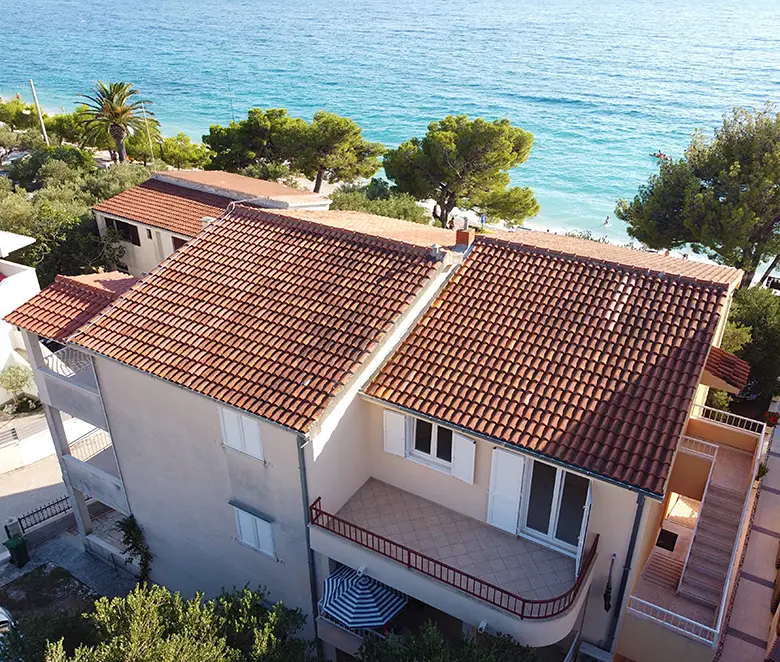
[154,170,328,204]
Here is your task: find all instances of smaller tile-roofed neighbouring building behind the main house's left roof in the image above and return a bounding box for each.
[93,170,330,276]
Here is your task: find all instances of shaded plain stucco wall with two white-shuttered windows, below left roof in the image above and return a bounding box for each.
[95,358,313,636]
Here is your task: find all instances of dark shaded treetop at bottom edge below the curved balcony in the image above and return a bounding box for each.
[359,622,536,662]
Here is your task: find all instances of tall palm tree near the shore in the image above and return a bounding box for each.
[79,80,159,163]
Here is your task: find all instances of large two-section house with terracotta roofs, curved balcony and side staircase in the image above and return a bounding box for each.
[7,209,764,662]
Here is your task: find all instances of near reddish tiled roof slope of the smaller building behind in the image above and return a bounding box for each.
[94,179,232,237]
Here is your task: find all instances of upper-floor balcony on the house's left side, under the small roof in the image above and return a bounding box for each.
[39,347,107,429]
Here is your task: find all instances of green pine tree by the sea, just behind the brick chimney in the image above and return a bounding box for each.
[384,115,539,227]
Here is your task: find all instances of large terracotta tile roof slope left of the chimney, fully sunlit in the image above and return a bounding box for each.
[69,206,437,432]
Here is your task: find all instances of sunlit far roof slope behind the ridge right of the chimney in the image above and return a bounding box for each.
[487,230,742,287]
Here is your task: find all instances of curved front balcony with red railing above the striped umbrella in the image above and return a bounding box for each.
[310,478,598,646]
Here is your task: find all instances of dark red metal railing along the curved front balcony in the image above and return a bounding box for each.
[309,497,599,618]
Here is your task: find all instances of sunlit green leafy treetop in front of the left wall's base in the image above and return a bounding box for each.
[46,585,313,662]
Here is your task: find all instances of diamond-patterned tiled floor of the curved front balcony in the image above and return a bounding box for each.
[337,478,574,600]
